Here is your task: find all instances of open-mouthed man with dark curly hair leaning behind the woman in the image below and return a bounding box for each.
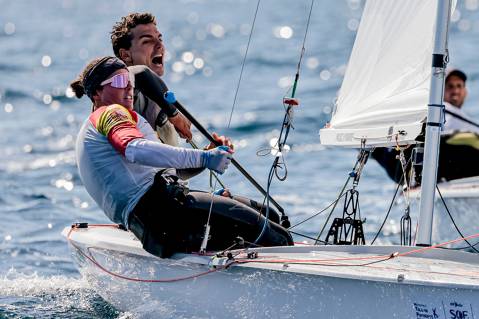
[111,13,233,180]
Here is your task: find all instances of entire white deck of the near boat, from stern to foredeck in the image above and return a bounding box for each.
[63,227,479,289]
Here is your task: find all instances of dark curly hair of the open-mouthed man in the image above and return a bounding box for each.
[110,12,156,58]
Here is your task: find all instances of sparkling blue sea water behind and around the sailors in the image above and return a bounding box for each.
[0,0,479,318]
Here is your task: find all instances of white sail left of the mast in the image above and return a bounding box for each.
[320,0,437,147]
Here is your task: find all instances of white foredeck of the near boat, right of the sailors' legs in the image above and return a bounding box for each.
[232,246,479,289]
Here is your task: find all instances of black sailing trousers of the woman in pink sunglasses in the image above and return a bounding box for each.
[129,173,293,258]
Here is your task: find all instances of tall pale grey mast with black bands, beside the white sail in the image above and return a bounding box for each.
[417,0,451,246]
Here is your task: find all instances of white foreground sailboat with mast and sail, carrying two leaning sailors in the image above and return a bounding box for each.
[63,0,479,319]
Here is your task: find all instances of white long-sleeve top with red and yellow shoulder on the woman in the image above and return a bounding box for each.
[76,104,203,225]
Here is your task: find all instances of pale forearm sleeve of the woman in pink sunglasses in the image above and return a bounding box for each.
[125,138,204,168]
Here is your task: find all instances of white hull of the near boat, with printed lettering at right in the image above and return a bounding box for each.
[64,228,479,319]
